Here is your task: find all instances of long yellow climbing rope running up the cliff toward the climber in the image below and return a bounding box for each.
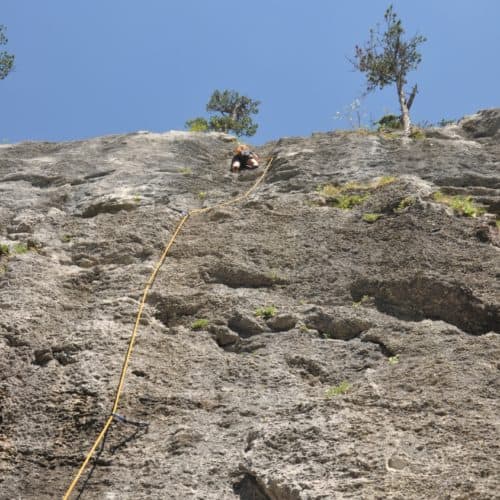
[63,157,273,500]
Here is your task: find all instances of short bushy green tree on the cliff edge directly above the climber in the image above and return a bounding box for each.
[186,90,260,137]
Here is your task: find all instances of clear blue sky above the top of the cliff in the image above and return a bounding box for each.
[0,0,500,144]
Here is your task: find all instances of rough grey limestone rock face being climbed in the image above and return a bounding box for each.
[0,110,500,500]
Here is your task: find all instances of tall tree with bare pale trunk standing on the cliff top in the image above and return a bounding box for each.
[351,5,426,135]
